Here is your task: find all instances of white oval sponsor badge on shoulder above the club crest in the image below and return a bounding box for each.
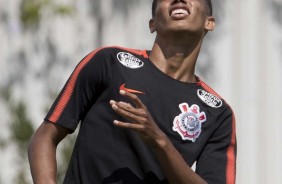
[197,89,222,108]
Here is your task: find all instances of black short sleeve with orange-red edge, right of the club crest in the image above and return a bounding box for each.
[196,108,237,184]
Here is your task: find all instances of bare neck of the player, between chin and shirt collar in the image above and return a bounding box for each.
[150,33,202,83]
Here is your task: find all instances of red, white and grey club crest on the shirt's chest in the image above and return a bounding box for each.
[172,103,207,142]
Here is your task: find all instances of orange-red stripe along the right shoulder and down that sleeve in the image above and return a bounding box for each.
[200,81,236,184]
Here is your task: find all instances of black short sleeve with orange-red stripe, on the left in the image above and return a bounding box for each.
[45,49,107,131]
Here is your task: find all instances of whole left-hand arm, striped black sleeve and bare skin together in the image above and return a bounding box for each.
[28,49,109,184]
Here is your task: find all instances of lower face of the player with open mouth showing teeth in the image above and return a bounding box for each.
[150,0,213,35]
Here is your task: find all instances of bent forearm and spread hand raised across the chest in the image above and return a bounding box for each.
[110,91,206,184]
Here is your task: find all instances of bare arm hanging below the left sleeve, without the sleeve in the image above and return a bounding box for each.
[28,121,68,184]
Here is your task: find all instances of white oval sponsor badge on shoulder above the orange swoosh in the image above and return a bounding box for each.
[117,52,144,69]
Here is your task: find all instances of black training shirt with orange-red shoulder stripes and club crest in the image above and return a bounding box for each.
[45,47,236,184]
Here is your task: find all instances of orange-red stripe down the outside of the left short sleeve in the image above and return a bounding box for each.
[49,48,102,123]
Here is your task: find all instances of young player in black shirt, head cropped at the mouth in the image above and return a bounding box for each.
[29,0,236,184]
